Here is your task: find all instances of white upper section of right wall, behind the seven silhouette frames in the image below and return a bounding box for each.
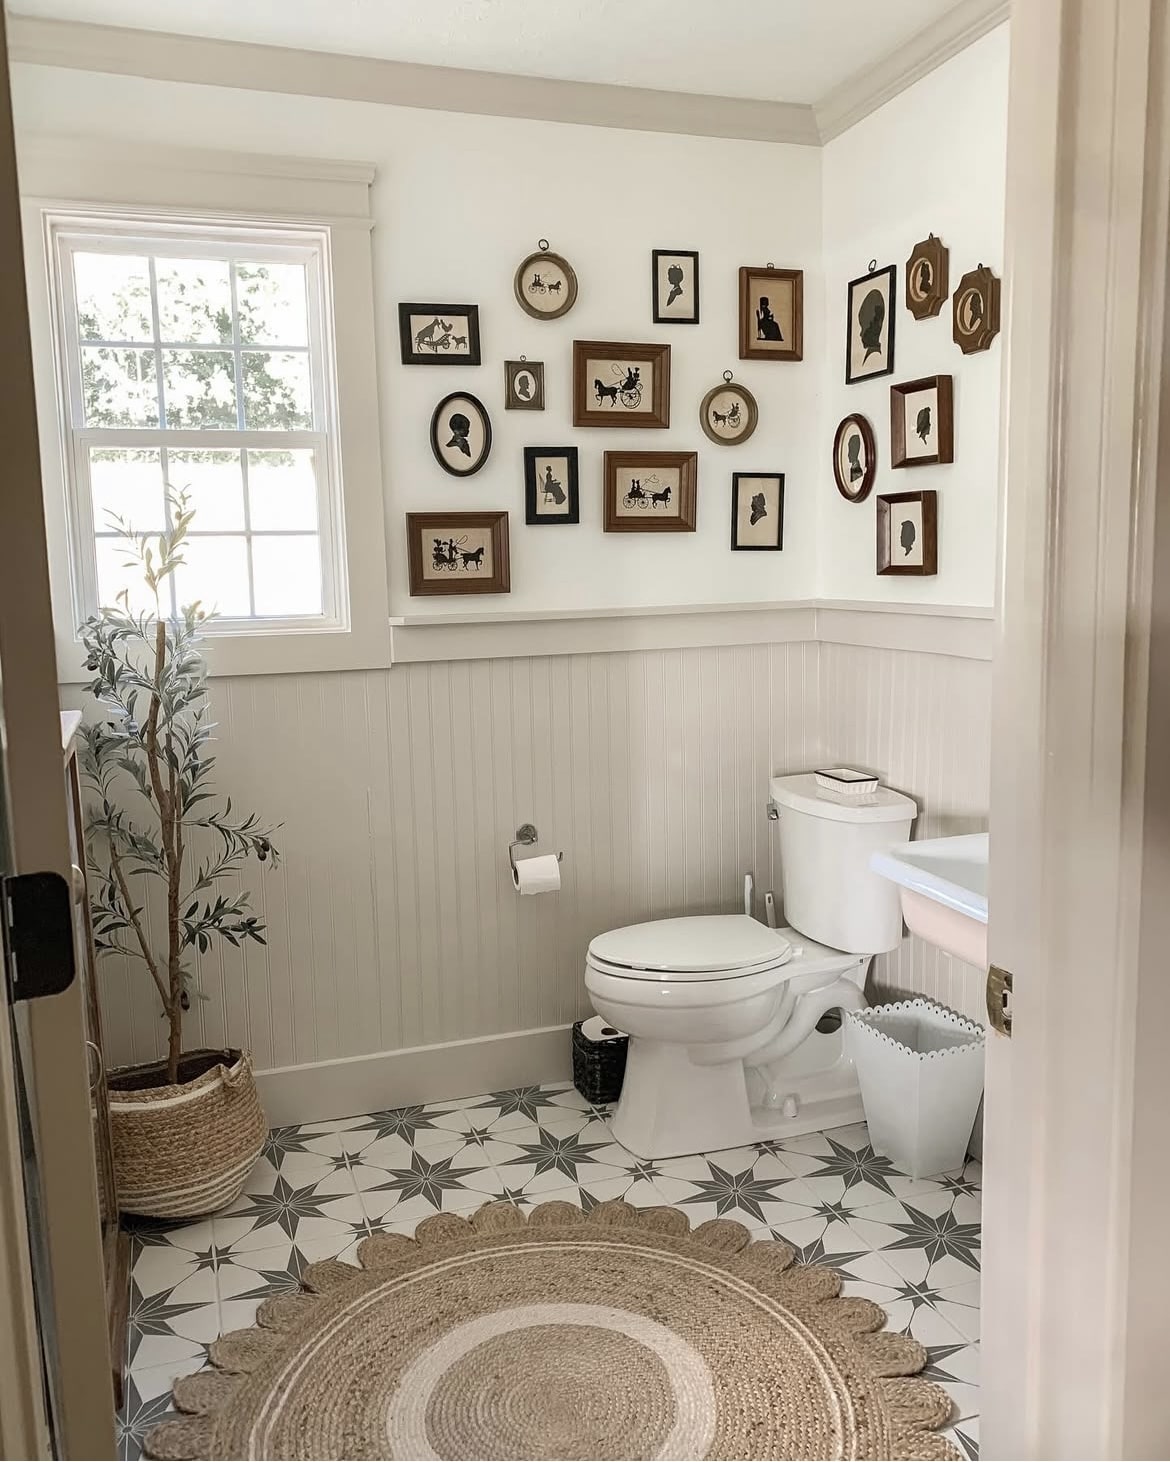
[816,25,1008,605]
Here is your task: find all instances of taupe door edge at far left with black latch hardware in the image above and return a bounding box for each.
[0,13,114,1458]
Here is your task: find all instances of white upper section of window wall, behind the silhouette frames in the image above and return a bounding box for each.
[13,66,823,614]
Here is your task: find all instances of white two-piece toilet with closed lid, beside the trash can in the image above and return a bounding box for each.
[585,773,917,1158]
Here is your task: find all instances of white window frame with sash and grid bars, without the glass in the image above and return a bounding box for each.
[45,209,350,636]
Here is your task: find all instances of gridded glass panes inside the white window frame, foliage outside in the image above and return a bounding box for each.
[69,230,326,621]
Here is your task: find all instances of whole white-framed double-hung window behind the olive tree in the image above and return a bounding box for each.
[51,216,348,635]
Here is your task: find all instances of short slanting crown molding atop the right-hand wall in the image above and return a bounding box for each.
[813,0,1011,143]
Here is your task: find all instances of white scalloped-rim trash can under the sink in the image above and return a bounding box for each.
[845,999,984,1178]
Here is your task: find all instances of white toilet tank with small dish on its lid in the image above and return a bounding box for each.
[771,772,918,955]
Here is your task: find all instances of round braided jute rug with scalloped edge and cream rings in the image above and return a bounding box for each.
[146,1202,958,1459]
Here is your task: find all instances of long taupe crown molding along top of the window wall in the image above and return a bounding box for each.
[9,15,820,148]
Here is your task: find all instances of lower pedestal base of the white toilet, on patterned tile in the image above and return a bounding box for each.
[610,1037,866,1159]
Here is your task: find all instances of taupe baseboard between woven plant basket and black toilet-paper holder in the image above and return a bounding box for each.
[256,1025,572,1127]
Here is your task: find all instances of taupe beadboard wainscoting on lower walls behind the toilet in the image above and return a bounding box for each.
[67,642,990,1121]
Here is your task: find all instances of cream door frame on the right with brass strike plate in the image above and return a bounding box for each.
[981,0,1170,1458]
